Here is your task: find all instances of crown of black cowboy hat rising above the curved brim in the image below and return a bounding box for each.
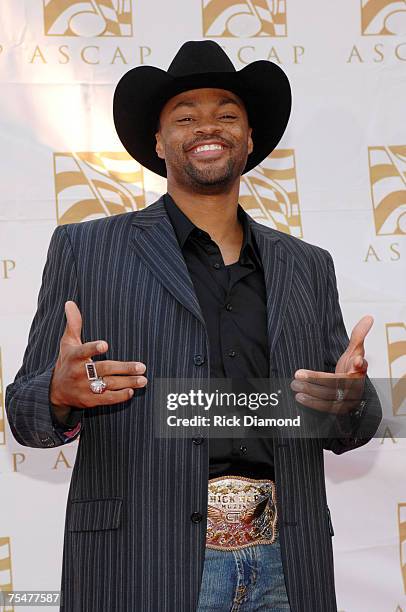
[168,40,236,77]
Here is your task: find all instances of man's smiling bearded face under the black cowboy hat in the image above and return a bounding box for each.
[156,88,253,193]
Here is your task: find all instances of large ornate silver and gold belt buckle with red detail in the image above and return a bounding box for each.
[206,476,277,550]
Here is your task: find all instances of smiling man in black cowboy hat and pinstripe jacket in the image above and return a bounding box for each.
[6,41,380,612]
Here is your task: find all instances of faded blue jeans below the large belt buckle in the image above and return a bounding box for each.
[196,538,290,612]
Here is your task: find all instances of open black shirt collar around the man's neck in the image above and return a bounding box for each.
[164,193,261,264]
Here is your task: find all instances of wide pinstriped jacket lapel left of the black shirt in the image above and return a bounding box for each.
[131,198,205,325]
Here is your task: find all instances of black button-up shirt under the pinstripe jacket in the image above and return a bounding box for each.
[164,194,274,479]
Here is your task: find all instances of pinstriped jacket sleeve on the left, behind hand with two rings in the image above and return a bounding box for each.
[5,226,82,448]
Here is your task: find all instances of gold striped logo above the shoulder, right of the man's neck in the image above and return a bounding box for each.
[240,149,303,238]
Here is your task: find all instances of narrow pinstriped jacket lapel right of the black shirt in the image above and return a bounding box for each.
[249,217,294,355]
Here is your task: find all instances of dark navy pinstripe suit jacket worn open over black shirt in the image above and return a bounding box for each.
[6,199,379,612]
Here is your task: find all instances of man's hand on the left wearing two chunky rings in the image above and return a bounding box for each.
[50,302,148,422]
